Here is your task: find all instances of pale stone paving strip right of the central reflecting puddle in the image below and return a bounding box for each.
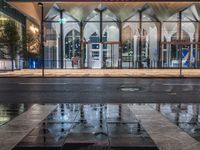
[129,105,200,150]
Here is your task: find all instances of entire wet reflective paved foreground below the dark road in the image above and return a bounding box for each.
[0,103,200,150]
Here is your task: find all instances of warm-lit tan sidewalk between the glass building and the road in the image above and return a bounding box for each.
[0,69,200,78]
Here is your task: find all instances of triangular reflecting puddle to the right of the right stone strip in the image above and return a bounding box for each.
[150,104,200,141]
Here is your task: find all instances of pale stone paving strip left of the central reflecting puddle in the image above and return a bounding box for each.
[0,104,57,150]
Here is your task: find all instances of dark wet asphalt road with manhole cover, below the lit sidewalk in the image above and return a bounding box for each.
[0,78,200,104]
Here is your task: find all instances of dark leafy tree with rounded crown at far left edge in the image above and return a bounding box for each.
[0,20,21,71]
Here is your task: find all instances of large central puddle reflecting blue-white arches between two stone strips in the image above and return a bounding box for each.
[15,104,157,150]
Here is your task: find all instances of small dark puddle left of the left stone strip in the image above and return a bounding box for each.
[0,104,30,126]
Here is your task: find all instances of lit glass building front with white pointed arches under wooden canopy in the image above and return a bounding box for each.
[7,0,200,68]
